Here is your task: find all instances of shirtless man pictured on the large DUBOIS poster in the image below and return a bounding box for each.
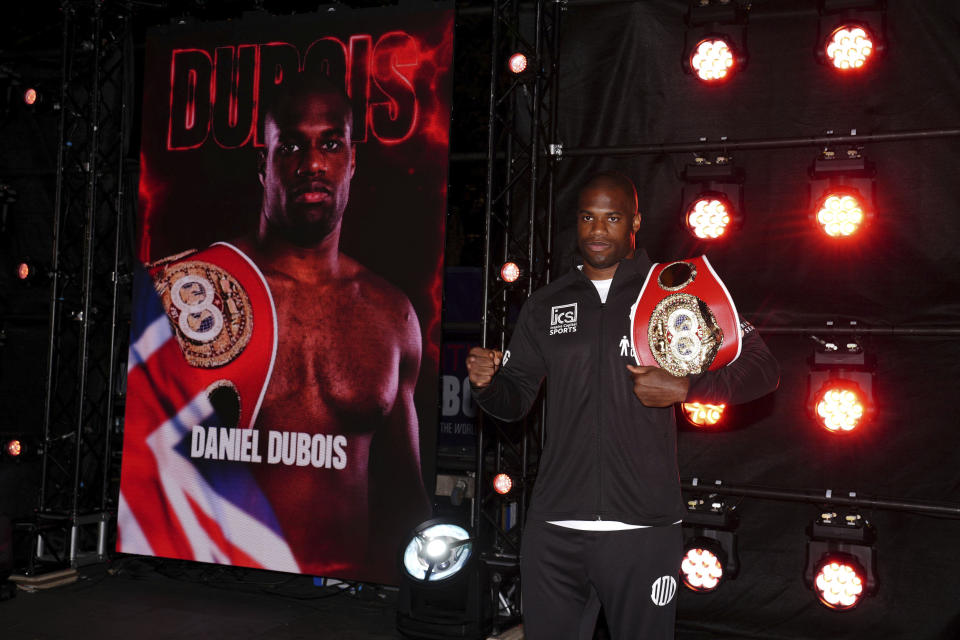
[231,75,429,582]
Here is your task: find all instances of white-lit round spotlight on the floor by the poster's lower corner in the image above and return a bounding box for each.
[397,519,493,640]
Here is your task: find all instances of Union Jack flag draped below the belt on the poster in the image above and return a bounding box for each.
[117,269,299,572]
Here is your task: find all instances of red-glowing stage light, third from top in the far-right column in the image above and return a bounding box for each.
[807,323,876,434]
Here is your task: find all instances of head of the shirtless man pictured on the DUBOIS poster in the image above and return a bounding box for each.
[260,93,356,245]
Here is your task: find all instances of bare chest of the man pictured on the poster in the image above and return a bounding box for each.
[265,282,399,431]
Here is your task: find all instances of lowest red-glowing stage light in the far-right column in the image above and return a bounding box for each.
[804,511,877,611]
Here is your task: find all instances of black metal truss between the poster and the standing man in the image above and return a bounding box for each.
[473,0,561,630]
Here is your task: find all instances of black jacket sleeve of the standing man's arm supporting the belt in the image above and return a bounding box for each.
[687,321,780,404]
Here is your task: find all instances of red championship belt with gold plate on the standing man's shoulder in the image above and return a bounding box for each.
[630,256,742,377]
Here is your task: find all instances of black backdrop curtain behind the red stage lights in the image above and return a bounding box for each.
[557,0,960,638]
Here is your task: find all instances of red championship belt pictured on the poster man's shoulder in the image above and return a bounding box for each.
[150,242,277,429]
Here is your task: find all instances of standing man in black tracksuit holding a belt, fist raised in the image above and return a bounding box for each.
[467,173,779,640]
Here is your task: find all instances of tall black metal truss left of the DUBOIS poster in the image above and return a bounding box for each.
[30,0,133,571]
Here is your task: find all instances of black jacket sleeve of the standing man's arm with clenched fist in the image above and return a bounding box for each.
[471,301,547,422]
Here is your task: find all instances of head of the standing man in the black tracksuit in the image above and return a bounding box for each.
[577,185,640,277]
